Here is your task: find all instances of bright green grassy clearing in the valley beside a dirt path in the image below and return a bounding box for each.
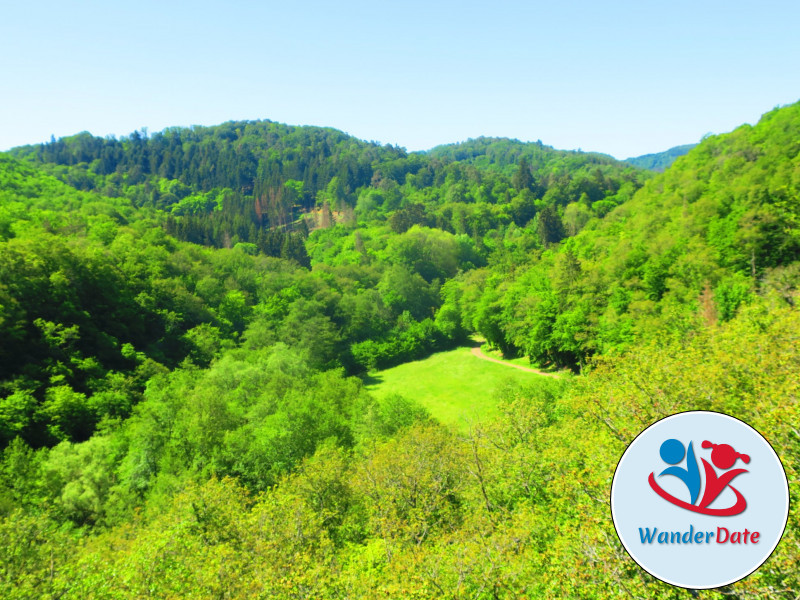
[365,346,543,430]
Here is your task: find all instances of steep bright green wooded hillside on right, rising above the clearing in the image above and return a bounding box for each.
[446,104,800,365]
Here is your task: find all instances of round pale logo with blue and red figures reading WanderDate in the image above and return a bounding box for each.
[611,411,789,589]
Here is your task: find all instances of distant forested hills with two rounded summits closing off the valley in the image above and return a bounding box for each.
[12,121,645,246]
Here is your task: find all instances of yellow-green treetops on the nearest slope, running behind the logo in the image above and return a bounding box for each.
[0,300,800,599]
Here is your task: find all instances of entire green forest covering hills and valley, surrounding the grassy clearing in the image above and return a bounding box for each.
[0,103,800,600]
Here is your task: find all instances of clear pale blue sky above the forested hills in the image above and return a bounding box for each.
[0,0,800,158]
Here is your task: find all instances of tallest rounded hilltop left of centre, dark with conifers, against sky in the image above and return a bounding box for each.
[11,121,404,204]
